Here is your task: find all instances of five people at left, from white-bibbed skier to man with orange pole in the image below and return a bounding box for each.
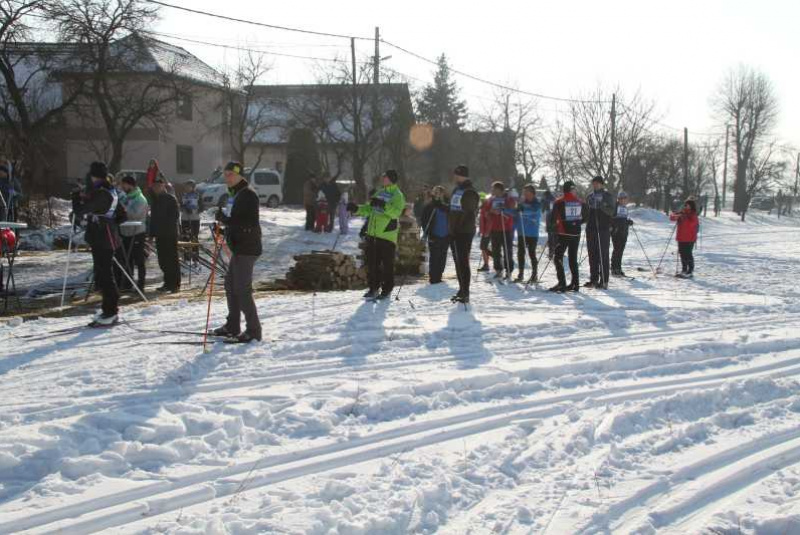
[73,162,261,343]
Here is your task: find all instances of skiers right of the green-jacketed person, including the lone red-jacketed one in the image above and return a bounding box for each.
[412,172,699,302]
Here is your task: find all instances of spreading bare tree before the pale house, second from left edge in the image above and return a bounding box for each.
[51,0,192,172]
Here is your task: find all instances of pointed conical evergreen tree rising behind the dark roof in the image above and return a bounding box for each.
[417,54,467,130]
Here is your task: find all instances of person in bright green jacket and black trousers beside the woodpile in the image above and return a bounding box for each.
[348,169,406,299]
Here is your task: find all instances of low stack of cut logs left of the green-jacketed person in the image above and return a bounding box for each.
[286,251,367,290]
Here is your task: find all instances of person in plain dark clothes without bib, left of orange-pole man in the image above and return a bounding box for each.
[150,177,181,293]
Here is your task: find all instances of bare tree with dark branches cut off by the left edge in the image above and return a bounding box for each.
[0,0,80,195]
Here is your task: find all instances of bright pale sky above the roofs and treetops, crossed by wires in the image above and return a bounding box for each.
[154,0,800,154]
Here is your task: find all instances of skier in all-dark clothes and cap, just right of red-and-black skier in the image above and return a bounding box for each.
[584,176,615,289]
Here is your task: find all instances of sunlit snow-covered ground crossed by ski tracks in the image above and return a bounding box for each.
[0,210,800,535]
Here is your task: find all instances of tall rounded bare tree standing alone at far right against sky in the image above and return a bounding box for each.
[714,65,778,220]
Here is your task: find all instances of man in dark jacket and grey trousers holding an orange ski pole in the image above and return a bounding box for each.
[213,162,261,344]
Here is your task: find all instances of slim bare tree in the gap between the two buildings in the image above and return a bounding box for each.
[221,51,276,169]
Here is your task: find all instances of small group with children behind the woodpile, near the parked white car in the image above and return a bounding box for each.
[303,175,350,234]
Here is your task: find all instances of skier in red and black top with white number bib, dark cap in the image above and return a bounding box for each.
[550,180,587,293]
